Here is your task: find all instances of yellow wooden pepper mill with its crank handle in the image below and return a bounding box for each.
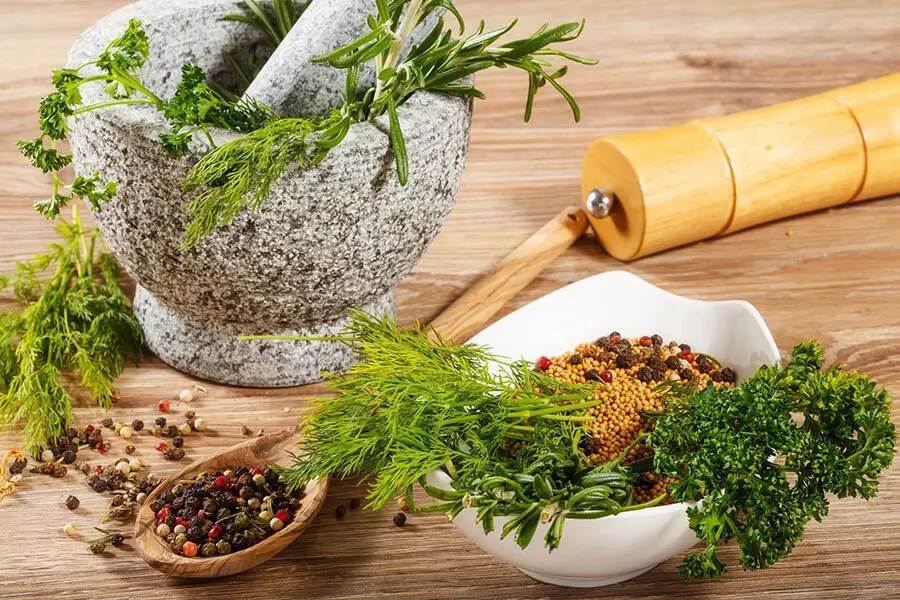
[432,74,900,342]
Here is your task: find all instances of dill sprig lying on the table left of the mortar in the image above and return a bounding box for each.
[0,210,143,451]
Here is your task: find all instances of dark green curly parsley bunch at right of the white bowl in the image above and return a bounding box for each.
[648,343,895,577]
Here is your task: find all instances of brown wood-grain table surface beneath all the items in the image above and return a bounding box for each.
[0,0,900,600]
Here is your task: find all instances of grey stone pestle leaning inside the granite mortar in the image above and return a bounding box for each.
[244,0,443,117]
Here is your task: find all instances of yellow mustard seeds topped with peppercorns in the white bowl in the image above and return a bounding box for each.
[537,331,737,503]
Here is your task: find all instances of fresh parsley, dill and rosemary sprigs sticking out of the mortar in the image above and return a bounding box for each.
[19,0,596,249]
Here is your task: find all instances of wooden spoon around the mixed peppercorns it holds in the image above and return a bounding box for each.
[134,427,328,578]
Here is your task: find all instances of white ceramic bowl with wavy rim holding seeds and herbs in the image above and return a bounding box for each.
[428,271,779,587]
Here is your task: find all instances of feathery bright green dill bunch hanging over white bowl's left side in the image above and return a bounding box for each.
[258,311,599,509]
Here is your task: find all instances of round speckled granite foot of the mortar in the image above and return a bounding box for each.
[134,286,394,387]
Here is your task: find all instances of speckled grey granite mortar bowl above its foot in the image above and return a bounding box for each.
[69,0,471,385]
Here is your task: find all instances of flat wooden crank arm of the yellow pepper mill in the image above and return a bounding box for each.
[431,206,587,343]
